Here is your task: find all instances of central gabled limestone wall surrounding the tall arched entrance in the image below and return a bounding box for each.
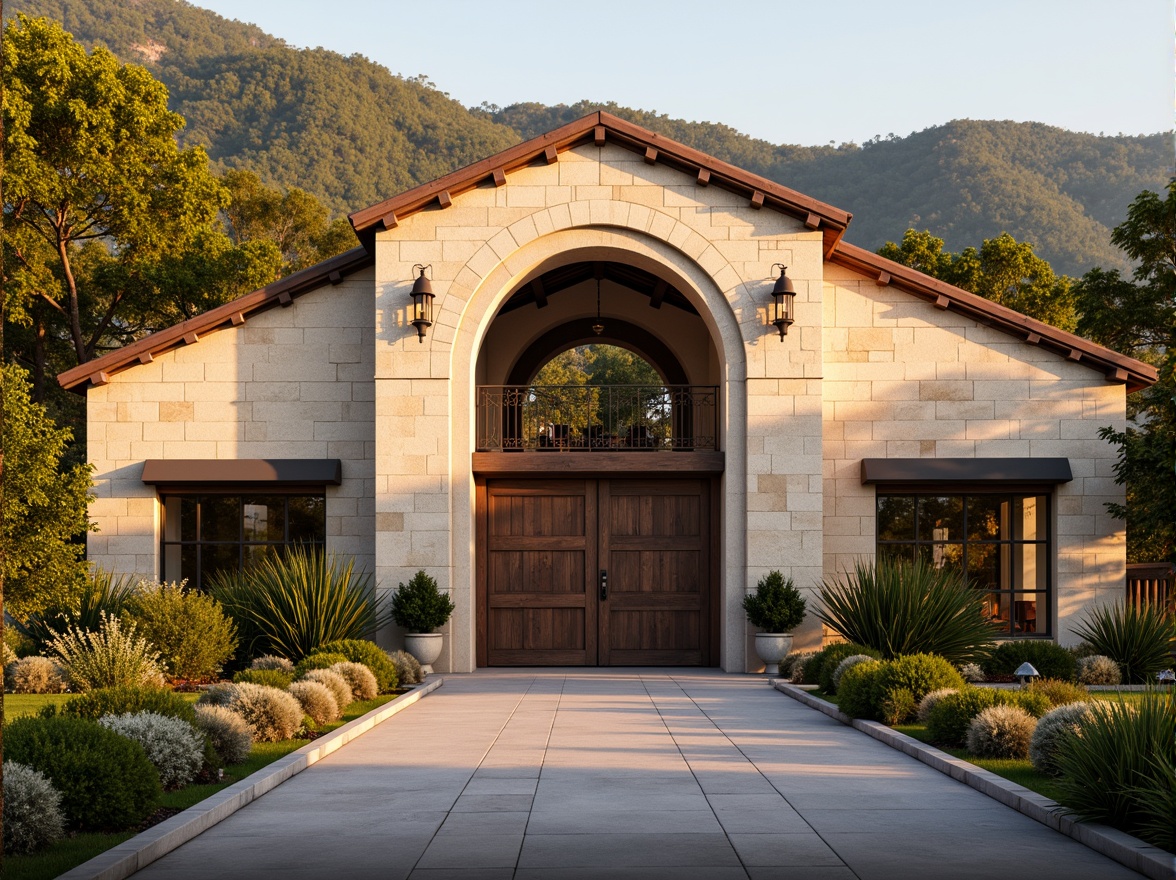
[375,145,823,671]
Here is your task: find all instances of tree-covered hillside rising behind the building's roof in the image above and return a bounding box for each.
[5,0,1172,275]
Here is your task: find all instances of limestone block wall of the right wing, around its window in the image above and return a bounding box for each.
[823,265,1125,644]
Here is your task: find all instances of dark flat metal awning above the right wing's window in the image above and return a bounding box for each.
[862,459,1074,486]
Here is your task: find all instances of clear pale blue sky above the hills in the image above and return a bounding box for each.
[193,0,1174,145]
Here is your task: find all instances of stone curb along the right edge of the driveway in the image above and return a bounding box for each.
[770,679,1176,880]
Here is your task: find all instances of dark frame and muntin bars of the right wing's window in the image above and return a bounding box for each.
[874,482,1057,640]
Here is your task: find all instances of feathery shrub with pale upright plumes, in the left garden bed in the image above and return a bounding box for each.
[49,612,163,691]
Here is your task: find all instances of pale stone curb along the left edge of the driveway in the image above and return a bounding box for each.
[58,678,445,880]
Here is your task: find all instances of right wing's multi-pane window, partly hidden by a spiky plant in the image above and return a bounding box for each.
[877,491,1053,636]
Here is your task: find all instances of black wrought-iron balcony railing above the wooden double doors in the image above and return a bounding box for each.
[476,385,719,452]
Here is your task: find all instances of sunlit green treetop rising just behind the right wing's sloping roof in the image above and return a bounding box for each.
[878,229,1077,332]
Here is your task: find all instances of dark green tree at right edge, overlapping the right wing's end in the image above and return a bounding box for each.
[1075,180,1176,564]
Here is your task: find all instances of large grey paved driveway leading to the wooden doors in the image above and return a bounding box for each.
[136,669,1140,880]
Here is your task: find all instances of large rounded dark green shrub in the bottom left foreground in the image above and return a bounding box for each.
[4,715,160,831]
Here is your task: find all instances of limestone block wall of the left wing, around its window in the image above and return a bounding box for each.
[87,269,375,576]
